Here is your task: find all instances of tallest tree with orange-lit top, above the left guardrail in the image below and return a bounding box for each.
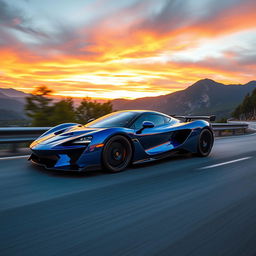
[25,86,52,126]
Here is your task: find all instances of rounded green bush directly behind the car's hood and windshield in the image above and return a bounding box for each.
[76,98,113,123]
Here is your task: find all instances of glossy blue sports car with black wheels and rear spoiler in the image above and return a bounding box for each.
[29,110,214,172]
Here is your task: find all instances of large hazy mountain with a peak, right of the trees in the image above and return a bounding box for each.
[112,79,256,118]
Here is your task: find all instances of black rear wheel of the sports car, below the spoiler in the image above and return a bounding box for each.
[197,128,214,157]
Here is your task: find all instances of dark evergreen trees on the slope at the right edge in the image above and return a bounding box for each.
[232,89,256,120]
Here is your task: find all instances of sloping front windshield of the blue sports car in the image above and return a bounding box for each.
[85,112,138,128]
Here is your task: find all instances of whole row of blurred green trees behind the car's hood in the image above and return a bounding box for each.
[25,86,113,126]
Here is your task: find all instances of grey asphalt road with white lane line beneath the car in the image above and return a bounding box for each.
[0,135,256,256]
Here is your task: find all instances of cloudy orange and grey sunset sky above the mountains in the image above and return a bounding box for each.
[0,0,256,99]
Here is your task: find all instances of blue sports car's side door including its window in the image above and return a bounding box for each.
[133,113,170,151]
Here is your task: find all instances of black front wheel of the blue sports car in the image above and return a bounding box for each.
[102,135,132,173]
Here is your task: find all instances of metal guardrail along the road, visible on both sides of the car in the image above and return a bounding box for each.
[0,123,248,152]
